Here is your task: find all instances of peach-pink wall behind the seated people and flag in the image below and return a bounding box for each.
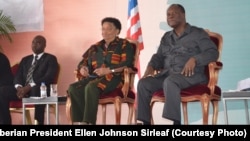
[1,0,167,124]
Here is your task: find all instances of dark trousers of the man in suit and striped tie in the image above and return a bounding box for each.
[0,86,45,124]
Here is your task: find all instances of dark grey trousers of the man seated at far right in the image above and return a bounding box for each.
[137,74,206,123]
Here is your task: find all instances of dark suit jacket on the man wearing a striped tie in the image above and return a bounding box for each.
[14,53,59,96]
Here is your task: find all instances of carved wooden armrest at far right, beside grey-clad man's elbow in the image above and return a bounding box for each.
[208,61,223,93]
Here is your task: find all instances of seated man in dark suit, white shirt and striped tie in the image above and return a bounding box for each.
[0,35,59,124]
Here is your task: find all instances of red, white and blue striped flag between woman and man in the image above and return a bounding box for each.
[127,0,144,78]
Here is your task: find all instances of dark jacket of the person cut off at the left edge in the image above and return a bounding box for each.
[0,53,13,87]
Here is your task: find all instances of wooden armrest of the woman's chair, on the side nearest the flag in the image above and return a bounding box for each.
[122,68,137,98]
